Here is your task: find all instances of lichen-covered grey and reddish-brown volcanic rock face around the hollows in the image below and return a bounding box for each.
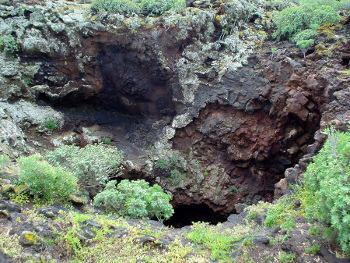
[0,1,350,217]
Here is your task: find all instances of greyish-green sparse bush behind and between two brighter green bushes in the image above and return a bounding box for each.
[47,144,123,195]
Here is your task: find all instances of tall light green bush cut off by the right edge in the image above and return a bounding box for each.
[302,129,350,255]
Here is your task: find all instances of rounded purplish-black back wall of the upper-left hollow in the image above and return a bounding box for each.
[96,45,175,118]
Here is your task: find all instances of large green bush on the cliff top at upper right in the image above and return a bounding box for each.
[273,0,345,48]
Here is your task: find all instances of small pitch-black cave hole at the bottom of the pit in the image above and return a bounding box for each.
[164,204,228,228]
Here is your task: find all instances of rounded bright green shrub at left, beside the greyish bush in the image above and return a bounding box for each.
[18,154,77,202]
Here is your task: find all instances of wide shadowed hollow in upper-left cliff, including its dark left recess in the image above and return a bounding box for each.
[34,43,176,119]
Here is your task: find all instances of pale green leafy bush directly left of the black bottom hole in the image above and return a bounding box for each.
[94,180,174,220]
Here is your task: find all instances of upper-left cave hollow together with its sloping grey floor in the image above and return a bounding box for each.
[37,43,176,162]
